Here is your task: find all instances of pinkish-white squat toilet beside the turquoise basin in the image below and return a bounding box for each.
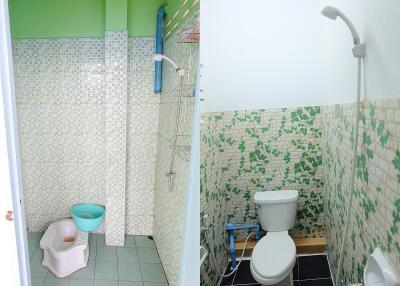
[40,219,89,278]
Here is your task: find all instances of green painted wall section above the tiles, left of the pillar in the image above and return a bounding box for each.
[9,0,105,38]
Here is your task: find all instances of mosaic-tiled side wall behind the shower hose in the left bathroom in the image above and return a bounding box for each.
[154,11,199,286]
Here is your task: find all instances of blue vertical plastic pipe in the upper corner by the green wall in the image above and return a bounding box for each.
[154,6,165,93]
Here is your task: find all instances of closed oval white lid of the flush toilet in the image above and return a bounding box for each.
[251,232,296,278]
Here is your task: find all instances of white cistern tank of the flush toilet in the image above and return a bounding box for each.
[254,190,299,231]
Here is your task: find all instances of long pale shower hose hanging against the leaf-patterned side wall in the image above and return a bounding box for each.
[335,57,362,286]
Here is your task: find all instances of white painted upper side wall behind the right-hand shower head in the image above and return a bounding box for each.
[321,0,400,101]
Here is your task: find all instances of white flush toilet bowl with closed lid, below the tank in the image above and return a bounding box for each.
[250,231,296,286]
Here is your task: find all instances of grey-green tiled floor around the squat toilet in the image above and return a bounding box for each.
[28,232,168,286]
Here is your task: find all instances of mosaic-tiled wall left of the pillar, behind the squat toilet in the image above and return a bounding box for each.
[13,38,106,231]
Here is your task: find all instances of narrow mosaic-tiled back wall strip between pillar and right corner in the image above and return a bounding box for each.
[125,37,160,235]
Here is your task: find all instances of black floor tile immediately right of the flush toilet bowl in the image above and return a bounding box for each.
[298,255,331,280]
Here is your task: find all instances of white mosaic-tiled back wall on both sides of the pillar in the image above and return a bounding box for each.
[13,37,159,238]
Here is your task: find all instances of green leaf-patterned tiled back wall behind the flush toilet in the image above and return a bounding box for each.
[201,107,325,285]
